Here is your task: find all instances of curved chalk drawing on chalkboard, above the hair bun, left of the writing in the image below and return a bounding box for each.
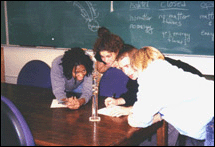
[73,1,99,32]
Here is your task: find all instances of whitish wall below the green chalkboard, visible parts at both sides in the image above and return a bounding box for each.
[3,46,214,84]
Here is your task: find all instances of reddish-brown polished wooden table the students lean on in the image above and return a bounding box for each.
[1,83,167,146]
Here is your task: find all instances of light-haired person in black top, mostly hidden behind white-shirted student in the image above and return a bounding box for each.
[111,44,203,117]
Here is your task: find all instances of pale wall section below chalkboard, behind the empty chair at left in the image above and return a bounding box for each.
[4,47,65,84]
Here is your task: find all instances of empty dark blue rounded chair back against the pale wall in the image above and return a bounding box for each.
[17,60,51,89]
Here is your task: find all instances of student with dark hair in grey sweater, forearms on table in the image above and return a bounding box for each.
[51,47,93,109]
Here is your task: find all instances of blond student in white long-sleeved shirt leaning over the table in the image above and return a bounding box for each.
[128,47,214,145]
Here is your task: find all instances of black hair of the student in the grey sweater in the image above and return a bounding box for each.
[60,47,93,80]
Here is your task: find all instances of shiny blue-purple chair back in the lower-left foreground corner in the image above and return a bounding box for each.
[1,96,35,146]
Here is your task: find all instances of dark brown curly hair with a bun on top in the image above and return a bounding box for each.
[93,27,124,60]
